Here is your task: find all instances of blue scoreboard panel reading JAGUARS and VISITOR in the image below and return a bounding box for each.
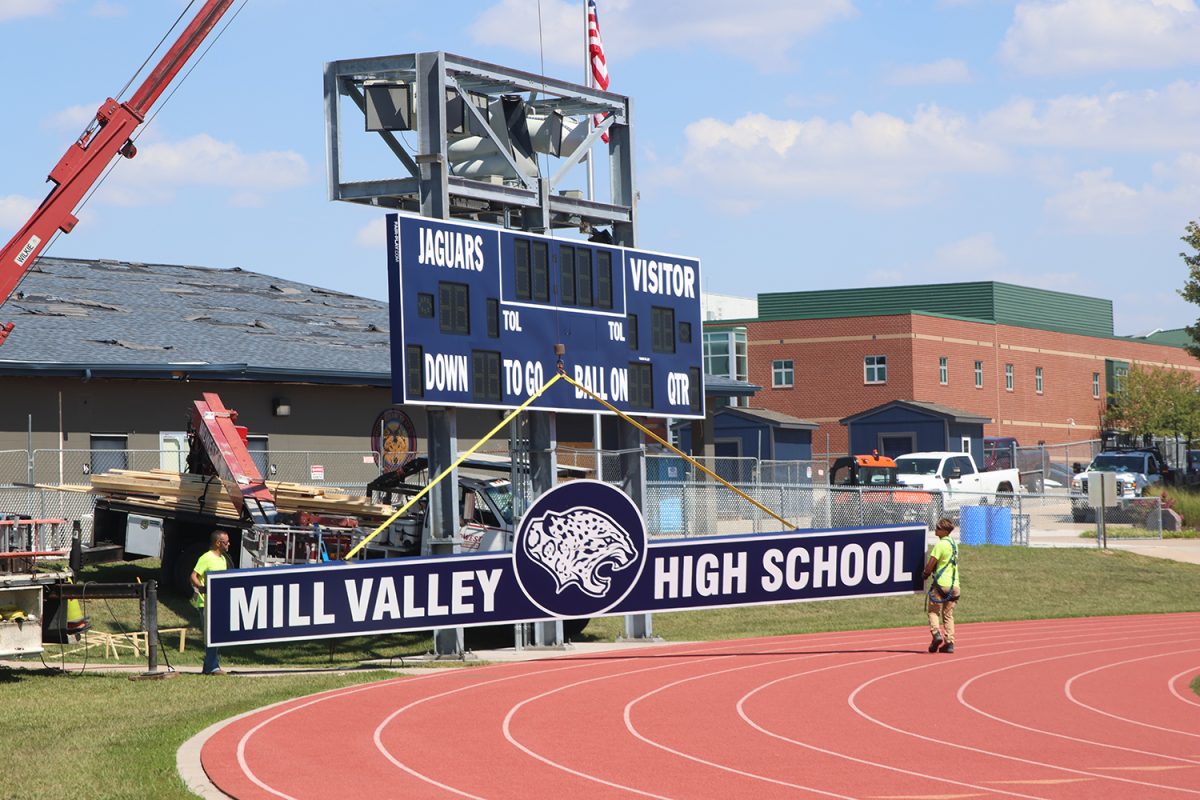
[388,213,704,419]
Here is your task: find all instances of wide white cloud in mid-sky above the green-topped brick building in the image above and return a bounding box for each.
[658,107,1006,212]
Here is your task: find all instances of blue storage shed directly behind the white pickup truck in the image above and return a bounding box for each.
[841,399,991,464]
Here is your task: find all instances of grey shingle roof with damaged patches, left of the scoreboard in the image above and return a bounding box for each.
[0,258,390,384]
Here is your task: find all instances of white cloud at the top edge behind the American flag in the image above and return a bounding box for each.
[469,0,856,69]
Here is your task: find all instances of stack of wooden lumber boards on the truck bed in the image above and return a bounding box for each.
[91,469,395,524]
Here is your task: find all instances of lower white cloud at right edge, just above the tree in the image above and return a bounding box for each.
[1045,154,1200,234]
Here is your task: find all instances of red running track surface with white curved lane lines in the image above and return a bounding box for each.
[202,614,1200,800]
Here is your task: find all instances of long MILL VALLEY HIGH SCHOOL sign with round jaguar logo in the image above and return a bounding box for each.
[205,481,925,646]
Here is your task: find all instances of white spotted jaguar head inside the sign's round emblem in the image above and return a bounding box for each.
[523,506,637,597]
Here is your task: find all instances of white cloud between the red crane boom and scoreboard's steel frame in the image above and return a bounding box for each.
[97,133,308,205]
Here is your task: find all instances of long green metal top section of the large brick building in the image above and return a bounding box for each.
[758,281,1112,337]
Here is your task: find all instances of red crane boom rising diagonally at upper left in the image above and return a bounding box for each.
[0,0,234,344]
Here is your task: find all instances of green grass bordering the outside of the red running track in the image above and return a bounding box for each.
[0,547,1200,800]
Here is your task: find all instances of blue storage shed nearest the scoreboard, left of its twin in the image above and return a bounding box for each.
[673,405,817,461]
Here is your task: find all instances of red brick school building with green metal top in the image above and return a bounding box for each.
[706,282,1200,452]
